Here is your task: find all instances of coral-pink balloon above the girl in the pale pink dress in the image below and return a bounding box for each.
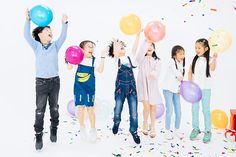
[144,21,165,42]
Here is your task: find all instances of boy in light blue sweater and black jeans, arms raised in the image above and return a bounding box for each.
[24,10,68,150]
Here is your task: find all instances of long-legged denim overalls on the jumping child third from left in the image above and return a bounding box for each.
[114,57,138,133]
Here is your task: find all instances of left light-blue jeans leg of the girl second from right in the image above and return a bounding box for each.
[163,90,173,130]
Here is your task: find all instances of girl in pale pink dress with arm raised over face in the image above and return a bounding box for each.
[133,33,162,138]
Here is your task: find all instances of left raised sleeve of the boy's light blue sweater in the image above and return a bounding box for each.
[24,20,38,50]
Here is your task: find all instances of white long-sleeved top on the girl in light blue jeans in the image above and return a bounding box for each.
[162,59,183,93]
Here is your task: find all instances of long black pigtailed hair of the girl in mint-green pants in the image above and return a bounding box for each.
[192,38,211,77]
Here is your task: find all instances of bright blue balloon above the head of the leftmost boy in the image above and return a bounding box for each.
[30,5,53,27]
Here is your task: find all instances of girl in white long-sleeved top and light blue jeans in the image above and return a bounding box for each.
[163,45,185,140]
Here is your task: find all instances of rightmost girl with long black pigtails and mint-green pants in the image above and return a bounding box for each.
[189,39,217,143]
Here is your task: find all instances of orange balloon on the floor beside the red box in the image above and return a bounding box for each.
[211,110,228,129]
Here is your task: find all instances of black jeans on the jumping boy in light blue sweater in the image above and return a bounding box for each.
[34,76,60,133]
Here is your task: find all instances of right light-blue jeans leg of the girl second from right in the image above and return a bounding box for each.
[173,94,181,129]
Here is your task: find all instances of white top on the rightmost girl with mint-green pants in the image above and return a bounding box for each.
[193,57,211,89]
